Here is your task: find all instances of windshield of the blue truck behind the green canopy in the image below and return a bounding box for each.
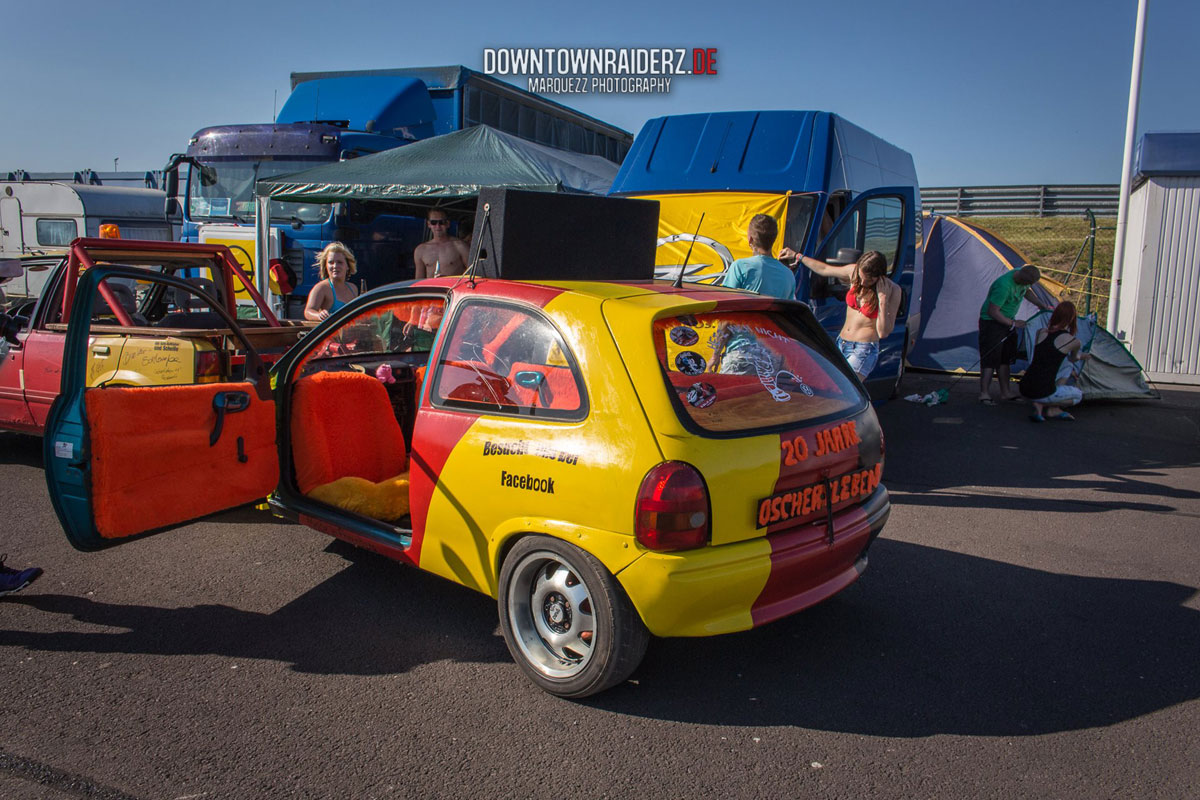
[187,158,334,223]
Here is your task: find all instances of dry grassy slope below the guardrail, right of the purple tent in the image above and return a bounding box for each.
[945,211,1116,323]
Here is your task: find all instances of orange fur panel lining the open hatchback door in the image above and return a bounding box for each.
[84,384,280,539]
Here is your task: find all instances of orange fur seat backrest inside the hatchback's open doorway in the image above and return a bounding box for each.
[290,372,408,494]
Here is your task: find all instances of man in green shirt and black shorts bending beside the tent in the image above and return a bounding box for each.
[979,264,1054,405]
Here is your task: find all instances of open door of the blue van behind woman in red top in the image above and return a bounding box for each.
[805,186,920,399]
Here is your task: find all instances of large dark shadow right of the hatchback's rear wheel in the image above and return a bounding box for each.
[588,539,1200,736]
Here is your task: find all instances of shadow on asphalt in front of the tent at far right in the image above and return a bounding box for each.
[877,375,1200,512]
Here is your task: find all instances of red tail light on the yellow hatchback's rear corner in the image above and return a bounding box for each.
[634,461,710,551]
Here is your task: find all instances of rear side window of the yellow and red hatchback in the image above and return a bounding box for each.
[431,302,587,420]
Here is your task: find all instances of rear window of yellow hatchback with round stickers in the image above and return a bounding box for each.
[654,312,864,433]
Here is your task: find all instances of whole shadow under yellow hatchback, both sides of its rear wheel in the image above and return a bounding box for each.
[9,539,1200,736]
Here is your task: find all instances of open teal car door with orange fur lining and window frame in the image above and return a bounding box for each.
[43,266,280,551]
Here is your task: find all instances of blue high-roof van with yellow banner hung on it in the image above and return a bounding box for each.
[611,112,922,399]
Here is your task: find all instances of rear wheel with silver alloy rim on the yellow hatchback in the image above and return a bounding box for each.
[499,536,650,698]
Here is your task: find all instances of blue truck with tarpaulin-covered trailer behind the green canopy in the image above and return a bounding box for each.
[167,66,632,318]
